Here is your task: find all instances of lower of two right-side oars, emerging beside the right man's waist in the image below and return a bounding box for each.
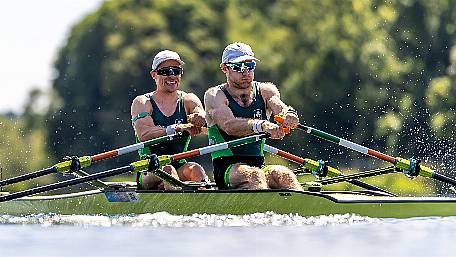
[264,144,391,194]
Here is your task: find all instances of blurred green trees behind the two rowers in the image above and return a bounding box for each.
[0,0,456,192]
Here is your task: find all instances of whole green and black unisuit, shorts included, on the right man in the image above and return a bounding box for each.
[208,81,267,189]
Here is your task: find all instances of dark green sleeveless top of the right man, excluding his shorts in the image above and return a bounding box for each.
[207,81,267,159]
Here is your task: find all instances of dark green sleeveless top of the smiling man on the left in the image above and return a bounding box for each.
[136,92,190,158]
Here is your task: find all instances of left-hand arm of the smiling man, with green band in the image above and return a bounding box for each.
[131,95,166,141]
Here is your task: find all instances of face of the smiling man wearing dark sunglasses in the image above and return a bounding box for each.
[150,60,182,93]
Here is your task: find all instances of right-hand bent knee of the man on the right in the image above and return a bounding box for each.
[265,165,304,191]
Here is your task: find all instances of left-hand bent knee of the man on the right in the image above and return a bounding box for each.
[227,163,268,189]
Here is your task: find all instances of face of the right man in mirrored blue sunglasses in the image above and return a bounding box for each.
[220,60,255,89]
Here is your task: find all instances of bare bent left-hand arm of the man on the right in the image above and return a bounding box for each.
[204,87,254,137]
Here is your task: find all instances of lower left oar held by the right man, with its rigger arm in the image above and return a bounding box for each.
[0,133,269,202]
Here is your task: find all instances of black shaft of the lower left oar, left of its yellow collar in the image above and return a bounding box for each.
[0,165,133,202]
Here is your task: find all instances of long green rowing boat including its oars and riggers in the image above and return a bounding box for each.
[0,124,456,218]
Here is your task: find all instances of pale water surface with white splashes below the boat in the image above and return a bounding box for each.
[0,212,456,257]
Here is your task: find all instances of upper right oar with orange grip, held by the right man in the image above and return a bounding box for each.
[274,115,456,186]
